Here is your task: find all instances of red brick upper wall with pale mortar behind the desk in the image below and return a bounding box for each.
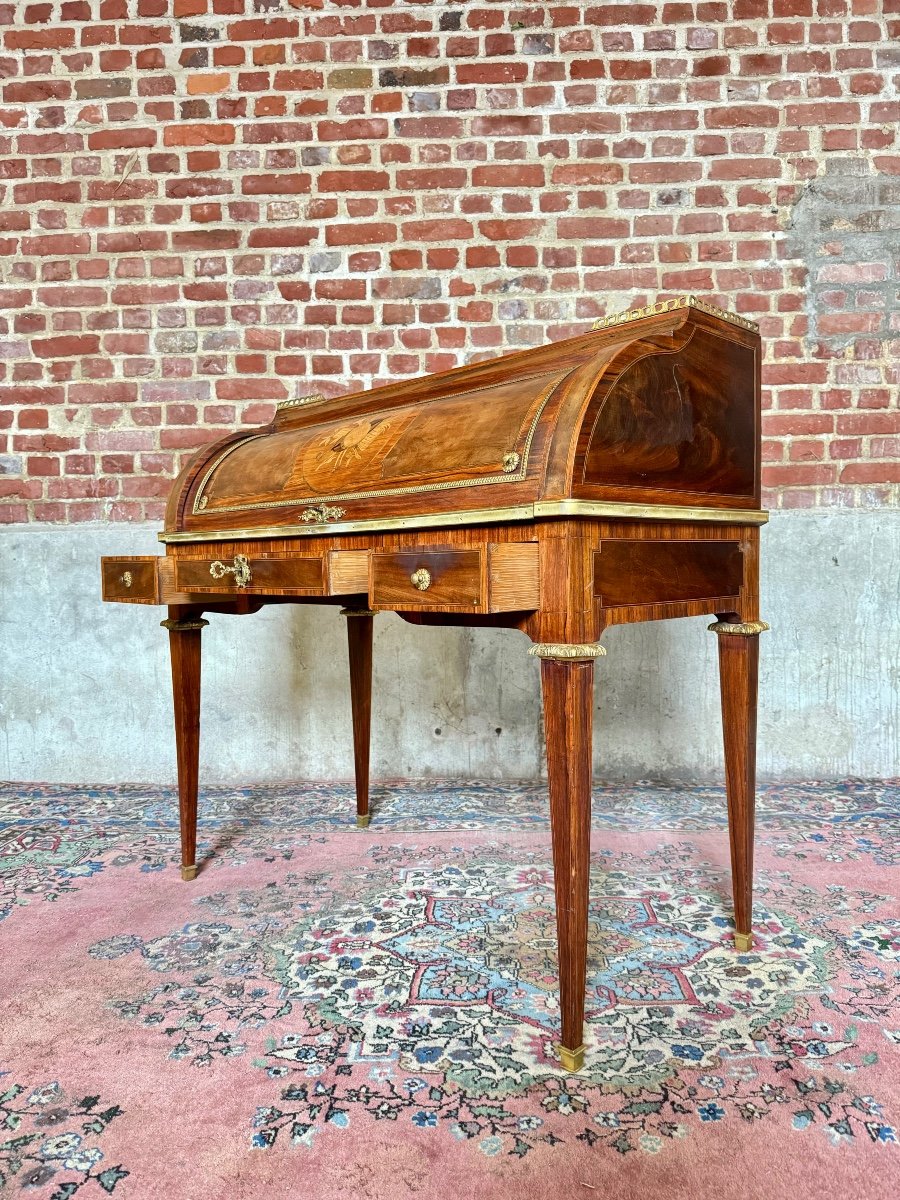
[0,0,900,522]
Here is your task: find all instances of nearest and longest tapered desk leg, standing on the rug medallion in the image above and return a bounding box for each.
[529,646,604,1072]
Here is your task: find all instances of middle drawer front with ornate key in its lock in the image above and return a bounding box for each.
[175,554,325,596]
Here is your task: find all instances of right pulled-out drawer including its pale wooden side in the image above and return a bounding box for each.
[370,542,540,612]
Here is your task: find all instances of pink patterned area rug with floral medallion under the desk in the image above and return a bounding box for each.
[0,781,900,1200]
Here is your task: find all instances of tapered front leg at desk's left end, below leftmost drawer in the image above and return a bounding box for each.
[161,610,209,881]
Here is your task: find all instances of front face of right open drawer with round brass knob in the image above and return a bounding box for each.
[370,548,485,612]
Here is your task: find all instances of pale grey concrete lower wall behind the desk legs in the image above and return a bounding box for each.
[0,510,900,784]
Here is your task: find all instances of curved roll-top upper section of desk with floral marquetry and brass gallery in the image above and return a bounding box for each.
[163,296,766,541]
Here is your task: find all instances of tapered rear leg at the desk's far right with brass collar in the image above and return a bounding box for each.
[709,620,769,950]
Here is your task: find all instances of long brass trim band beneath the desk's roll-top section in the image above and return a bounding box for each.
[158,500,769,545]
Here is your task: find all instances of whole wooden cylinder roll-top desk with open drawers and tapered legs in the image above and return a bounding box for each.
[102,296,767,1070]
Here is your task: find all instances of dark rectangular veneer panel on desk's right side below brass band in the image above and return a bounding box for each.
[594,539,744,608]
